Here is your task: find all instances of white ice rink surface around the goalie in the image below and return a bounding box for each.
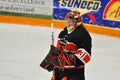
[0,24,120,80]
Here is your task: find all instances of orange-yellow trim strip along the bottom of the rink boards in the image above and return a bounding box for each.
[0,16,120,38]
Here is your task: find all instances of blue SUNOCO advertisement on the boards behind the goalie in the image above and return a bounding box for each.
[53,0,120,28]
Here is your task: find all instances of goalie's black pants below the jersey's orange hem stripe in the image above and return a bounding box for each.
[55,68,85,80]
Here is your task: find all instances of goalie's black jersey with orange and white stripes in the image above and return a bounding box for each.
[57,24,92,66]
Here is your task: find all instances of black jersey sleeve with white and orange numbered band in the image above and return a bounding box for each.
[75,29,92,64]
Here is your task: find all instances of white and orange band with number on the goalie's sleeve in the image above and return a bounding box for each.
[75,48,90,64]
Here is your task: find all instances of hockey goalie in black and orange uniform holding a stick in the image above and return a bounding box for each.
[40,11,92,80]
